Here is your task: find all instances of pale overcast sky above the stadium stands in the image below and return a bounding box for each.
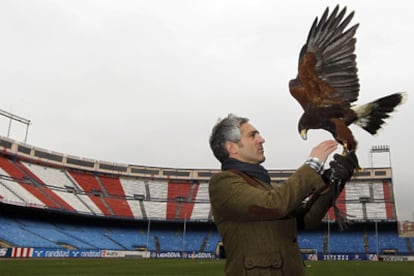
[0,0,414,219]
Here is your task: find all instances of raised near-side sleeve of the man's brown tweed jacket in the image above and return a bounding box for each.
[209,165,325,221]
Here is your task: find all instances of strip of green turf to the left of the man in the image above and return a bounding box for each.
[0,259,224,276]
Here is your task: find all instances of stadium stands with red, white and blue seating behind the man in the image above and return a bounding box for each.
[0,109,414,272]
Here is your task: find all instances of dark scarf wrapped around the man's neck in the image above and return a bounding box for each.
[221,158,270,184]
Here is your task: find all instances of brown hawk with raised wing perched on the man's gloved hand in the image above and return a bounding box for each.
[289,6,405,151]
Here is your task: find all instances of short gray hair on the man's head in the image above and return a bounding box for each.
[209,113,249,163]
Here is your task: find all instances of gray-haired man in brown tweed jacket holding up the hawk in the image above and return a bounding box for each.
[209,114,357,276]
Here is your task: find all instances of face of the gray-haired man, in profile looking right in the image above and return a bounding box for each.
[228,123,265,164]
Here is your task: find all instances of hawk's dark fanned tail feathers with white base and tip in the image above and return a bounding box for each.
[352,92,407,135]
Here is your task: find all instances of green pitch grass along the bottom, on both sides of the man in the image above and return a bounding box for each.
[0,259,414,276]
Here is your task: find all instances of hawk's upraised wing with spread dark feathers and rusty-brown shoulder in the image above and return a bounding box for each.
[289,6,359,109]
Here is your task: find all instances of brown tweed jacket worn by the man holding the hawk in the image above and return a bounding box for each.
[209,165,332,276]
